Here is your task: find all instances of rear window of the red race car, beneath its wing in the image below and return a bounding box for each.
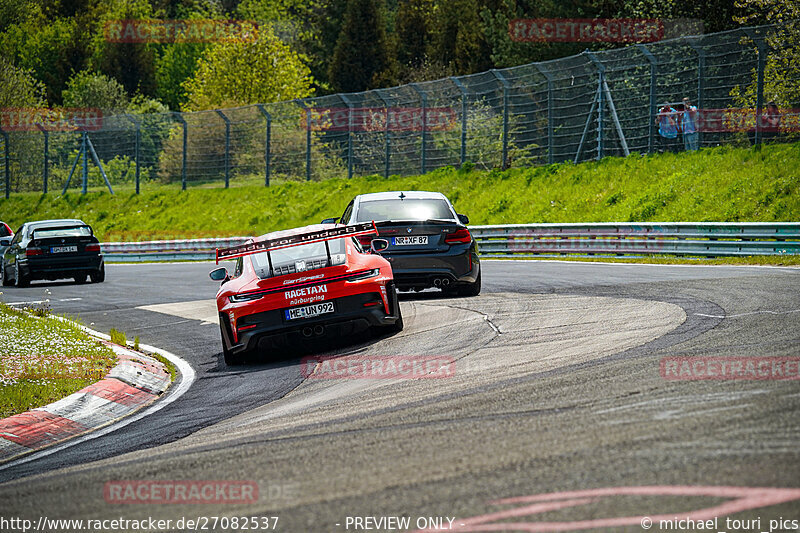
[250,238,347,279]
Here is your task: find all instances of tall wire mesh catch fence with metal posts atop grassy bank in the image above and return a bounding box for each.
[0,26,800,196]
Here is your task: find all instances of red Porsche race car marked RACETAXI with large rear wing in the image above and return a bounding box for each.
[209,222,403,365]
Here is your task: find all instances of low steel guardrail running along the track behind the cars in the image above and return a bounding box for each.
[101,222,800,263]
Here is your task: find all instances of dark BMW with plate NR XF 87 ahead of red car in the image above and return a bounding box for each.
[324,191,481,296]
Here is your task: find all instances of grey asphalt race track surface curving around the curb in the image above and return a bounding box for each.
[0,261,800,531]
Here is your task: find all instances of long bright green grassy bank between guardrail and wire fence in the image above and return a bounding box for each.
[0,143,800,241]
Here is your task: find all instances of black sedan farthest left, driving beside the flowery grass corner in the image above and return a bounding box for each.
[0,219,106,287]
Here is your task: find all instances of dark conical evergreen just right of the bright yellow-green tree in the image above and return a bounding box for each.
[328,0,390,92]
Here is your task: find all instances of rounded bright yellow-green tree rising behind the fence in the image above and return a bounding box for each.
[183,28,312,111]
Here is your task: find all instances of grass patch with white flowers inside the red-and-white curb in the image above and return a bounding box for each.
[0,303,117,418]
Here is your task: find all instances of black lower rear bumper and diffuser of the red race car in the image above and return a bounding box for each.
[220,290,400,354]
